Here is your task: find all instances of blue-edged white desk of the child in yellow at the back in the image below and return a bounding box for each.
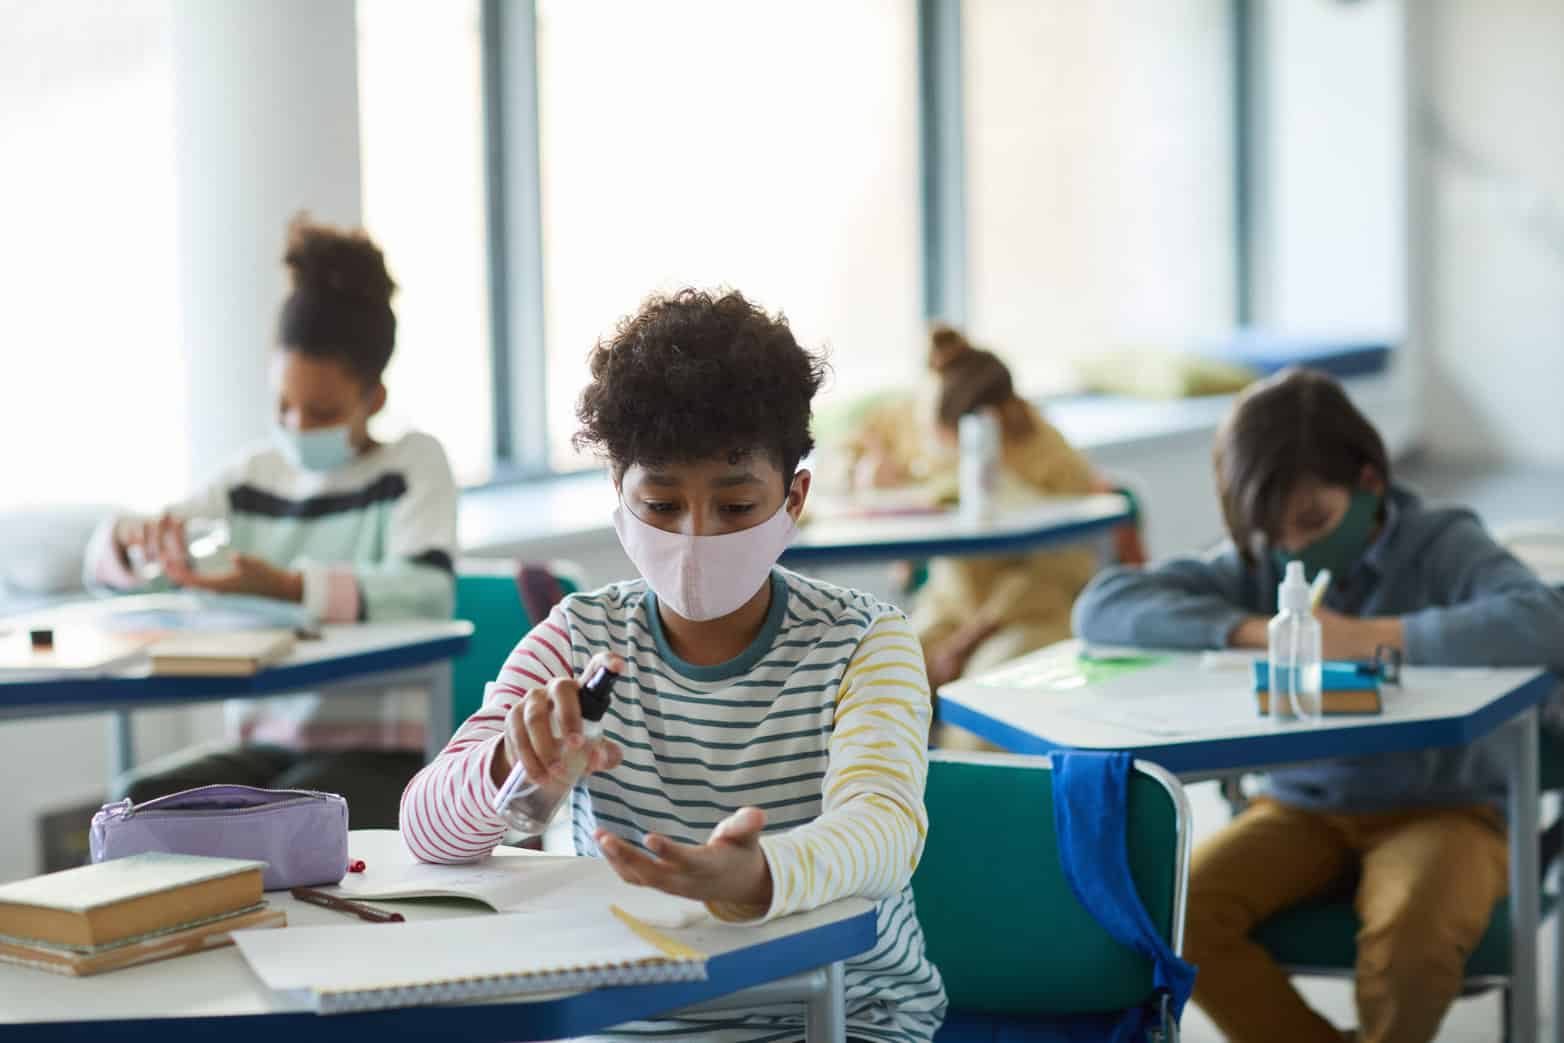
[782,493,1134,568]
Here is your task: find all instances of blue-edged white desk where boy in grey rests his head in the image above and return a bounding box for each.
[940,643,1564,1043]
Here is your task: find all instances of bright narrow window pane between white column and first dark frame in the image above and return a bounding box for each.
[358,0,494,483]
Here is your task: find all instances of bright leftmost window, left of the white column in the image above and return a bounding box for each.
[0,0,188,507]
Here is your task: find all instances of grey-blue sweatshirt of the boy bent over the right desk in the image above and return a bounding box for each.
[1074,486,1564,812]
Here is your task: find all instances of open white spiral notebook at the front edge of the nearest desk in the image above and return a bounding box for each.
[233,905,705,1013]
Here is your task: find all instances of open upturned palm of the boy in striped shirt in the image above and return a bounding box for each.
[596,807,771,910]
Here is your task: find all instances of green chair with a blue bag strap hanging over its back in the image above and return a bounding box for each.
[912,751,1189,1043]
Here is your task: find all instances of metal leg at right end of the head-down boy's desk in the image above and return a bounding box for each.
[1508,708,1538,1043]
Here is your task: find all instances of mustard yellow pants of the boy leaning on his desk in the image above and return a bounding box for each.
[1184,799,1509,1043]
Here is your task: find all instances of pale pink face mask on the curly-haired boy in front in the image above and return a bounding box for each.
[613,504,798,621]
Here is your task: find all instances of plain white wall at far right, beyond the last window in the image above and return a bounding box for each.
[1409,0,1564,466]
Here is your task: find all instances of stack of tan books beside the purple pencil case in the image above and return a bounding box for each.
[0,852,286,974]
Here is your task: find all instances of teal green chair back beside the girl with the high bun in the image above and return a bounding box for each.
[450,558,582,726]
